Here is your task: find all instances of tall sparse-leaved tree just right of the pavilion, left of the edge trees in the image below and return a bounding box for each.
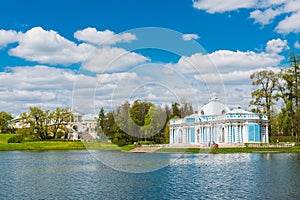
[250,70,277,133]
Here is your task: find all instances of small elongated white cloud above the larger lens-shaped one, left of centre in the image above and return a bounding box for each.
[74,27,137,45]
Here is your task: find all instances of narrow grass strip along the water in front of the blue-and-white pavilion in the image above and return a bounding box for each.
[155,146,300,153]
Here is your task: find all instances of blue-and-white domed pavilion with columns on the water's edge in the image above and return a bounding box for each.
[170,96,269,145]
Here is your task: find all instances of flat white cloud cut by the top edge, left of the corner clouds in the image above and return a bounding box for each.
[193,0,257,14]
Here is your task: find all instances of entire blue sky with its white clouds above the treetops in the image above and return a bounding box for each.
[0,0,300,114]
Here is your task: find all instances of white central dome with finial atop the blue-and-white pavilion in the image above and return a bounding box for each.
[199,95,230,116]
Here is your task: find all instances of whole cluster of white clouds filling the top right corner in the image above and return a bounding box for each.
[193,0,300,34]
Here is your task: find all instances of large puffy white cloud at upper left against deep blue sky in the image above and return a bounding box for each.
[9,27,94,65]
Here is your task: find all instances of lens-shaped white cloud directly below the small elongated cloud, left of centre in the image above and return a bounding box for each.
[82,47,149,73]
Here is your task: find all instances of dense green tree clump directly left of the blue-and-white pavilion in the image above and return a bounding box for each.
[97,100,194,146]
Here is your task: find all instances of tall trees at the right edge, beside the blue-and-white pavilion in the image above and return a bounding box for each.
[250,52,300,140]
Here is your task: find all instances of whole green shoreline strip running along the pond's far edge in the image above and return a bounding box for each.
[0,141,300,154]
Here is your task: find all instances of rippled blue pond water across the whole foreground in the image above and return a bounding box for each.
[0,151,300,199]
